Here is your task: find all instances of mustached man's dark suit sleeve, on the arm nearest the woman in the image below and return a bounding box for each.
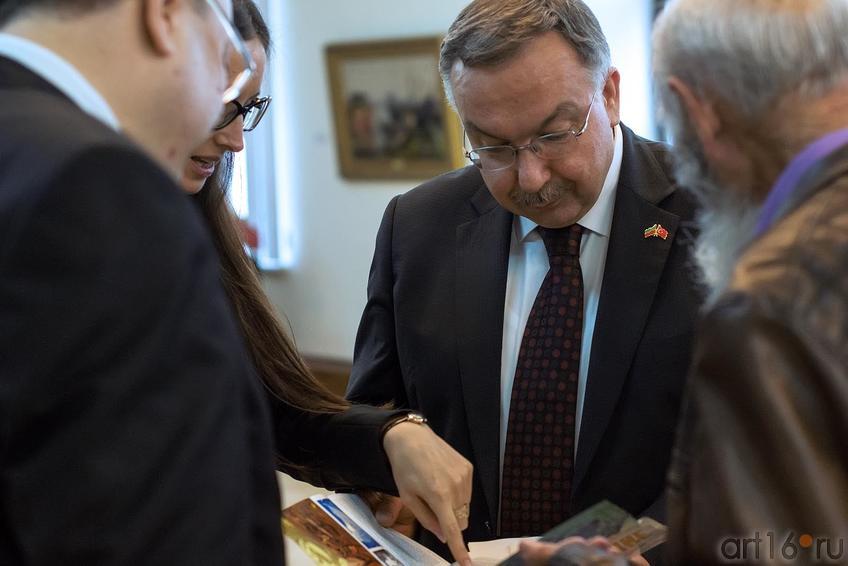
[347,197,409,408]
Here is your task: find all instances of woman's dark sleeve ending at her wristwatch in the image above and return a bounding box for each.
[272,399,406,495]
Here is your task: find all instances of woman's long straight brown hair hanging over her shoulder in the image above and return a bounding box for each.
[192,0,350,413]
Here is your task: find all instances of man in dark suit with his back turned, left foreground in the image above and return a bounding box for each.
[0,0,282,566]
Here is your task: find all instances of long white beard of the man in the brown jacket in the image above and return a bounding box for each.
[667,120,760,307]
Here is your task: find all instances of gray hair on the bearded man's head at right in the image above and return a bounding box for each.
[653,0,848,127]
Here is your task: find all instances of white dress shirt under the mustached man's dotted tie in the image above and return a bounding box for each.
[500,126,623,488]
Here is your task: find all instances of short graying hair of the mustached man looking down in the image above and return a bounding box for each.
[439,0,611,104]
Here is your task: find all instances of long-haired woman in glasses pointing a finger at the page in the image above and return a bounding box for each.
[182,0,472,563]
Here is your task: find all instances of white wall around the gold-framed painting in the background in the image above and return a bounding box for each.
[258,0,654,360]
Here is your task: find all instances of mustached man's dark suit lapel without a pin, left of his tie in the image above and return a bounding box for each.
[456,184,512,525]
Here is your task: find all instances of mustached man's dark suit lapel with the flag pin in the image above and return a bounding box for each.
[574,127,679,489]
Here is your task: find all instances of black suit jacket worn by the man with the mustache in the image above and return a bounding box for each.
[348,128,699,548]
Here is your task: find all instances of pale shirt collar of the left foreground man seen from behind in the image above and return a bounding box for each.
[0,33,121,130]
